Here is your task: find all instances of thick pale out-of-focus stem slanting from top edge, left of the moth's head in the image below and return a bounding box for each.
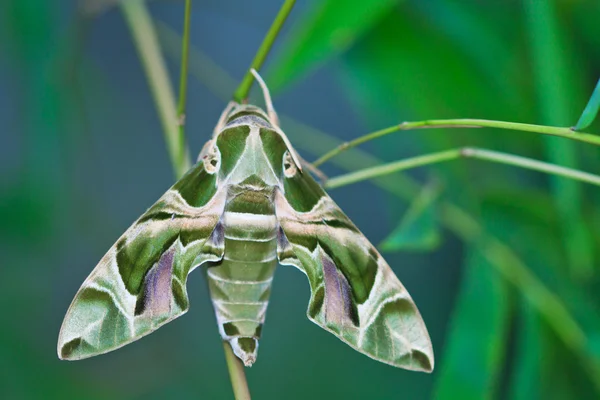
[119,0,191,178]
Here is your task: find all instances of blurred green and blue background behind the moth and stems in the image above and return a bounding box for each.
[0,0,600,399]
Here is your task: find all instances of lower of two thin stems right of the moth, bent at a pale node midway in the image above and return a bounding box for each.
[325,147,600,189]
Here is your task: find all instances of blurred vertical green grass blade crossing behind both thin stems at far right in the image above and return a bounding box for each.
[523,0,594,279]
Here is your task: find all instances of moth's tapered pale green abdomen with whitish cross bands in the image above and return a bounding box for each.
[208,190,277,365]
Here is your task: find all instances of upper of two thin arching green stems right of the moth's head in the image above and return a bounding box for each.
[313,118,600,167]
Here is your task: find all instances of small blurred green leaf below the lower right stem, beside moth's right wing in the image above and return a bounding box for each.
[379,185,440,251]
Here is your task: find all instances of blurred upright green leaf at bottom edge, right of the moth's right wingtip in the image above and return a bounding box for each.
[434,247,511,399]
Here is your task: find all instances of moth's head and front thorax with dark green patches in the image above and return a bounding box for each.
[201,104,301,186]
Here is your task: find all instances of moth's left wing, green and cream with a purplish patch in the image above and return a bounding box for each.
[58,162,225,360]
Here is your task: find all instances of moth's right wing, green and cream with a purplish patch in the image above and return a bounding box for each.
[275,174,434,372]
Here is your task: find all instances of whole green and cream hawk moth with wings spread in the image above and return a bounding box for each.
[58,75,434,372]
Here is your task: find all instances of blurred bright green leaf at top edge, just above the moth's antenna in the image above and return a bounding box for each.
[267,0,399,91]
